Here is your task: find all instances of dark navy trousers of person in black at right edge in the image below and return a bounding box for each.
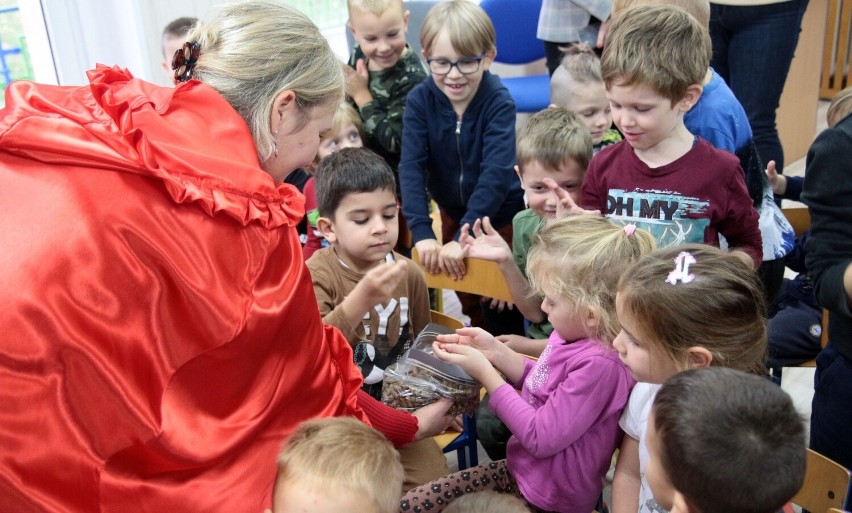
[810,342,852,468]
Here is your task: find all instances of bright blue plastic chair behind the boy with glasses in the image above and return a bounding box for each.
[479,0,550,112]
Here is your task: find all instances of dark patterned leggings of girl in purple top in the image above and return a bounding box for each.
[399,460,545,513]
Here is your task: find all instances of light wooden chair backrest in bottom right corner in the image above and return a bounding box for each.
[792,449,850,512]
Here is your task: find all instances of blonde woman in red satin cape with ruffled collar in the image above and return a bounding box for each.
[0,0,448,512]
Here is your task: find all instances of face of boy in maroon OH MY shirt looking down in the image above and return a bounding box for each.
[607,80,691,152]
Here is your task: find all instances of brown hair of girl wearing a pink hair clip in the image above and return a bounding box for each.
[618,244,766,374]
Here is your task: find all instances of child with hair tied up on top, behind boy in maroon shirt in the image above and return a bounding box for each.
[550,44,621,154]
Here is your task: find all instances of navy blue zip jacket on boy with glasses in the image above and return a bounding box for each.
[399,71,524,243]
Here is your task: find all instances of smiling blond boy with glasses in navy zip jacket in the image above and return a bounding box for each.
[399,0,523,284]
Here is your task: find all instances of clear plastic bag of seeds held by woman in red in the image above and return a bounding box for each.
[382,323,482,415]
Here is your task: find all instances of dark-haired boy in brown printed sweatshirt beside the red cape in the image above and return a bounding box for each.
[307,148,447,491]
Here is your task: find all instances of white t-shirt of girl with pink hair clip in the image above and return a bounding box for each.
[618,383,668,513]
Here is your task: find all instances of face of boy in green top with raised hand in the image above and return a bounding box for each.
[516,159,586,219]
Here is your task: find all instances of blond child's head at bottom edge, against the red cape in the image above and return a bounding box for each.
[272,417,402,513]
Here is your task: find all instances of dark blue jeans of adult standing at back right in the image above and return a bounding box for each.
[710,0,808,173]
